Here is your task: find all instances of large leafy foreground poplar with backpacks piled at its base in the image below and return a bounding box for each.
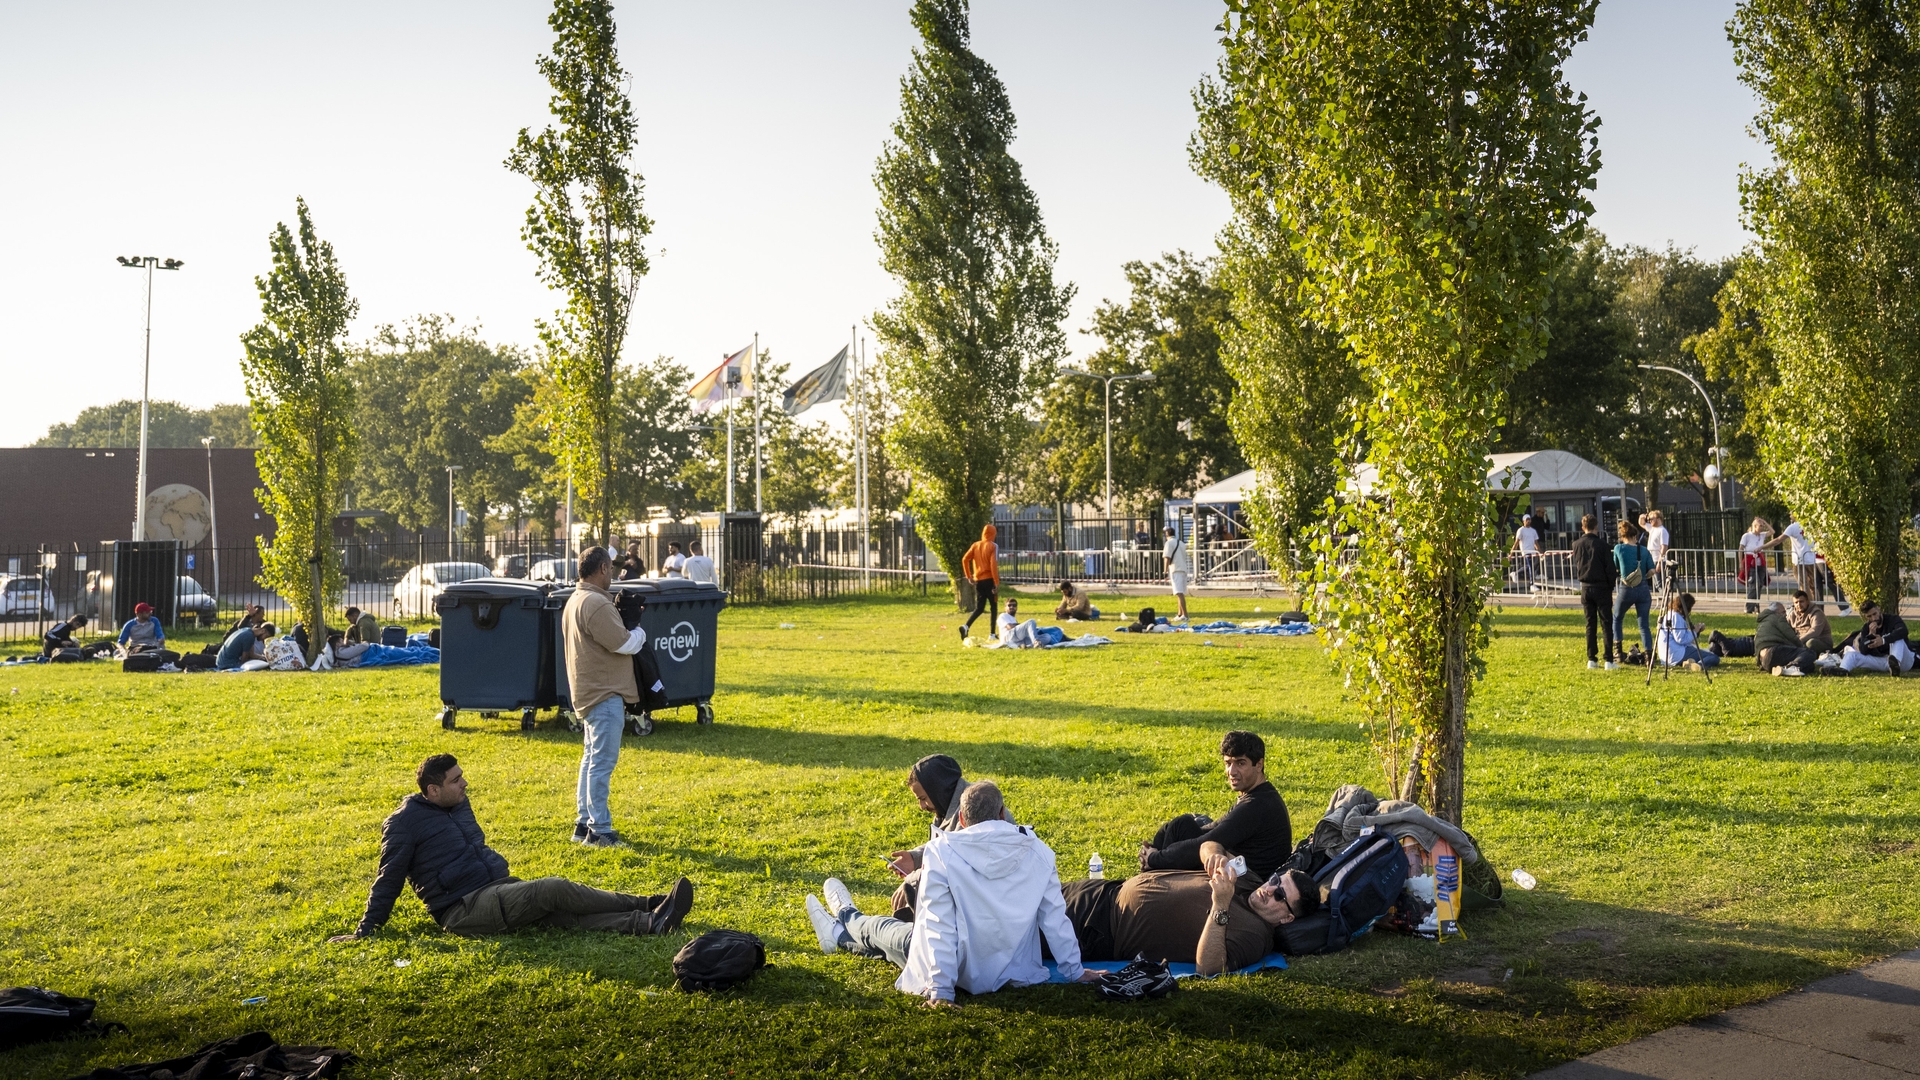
[1223,0,1599,822]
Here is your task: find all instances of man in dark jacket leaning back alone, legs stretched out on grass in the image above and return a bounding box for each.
[328,753,693,942]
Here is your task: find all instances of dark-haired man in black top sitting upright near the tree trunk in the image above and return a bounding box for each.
[1140,730,1294,880]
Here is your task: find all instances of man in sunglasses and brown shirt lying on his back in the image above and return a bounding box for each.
[1060,844,1321,976]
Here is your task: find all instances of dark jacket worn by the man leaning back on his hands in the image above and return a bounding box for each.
[357,794,507,934]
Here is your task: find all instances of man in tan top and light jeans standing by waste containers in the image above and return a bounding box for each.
[561,548,647,847]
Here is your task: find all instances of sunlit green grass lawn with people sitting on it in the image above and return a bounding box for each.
[0,600,1920,1078]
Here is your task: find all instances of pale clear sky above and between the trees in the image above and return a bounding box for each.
[0,0,1761,446]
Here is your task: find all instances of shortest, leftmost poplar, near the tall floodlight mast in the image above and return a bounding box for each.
[240,200,359,661]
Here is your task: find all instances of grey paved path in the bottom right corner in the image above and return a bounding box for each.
[1534,949,1920,1080]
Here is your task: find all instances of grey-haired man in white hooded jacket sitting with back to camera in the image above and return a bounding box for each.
[806,780,1100,1009]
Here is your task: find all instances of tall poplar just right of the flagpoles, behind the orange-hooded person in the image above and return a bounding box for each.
[874,0,1073,605]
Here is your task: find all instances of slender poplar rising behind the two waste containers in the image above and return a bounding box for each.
[507,0,653,542]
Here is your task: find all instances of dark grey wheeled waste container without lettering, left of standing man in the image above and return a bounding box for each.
[434,578,559,730]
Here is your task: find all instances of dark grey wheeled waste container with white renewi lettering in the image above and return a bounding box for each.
[553,578,728,734]
